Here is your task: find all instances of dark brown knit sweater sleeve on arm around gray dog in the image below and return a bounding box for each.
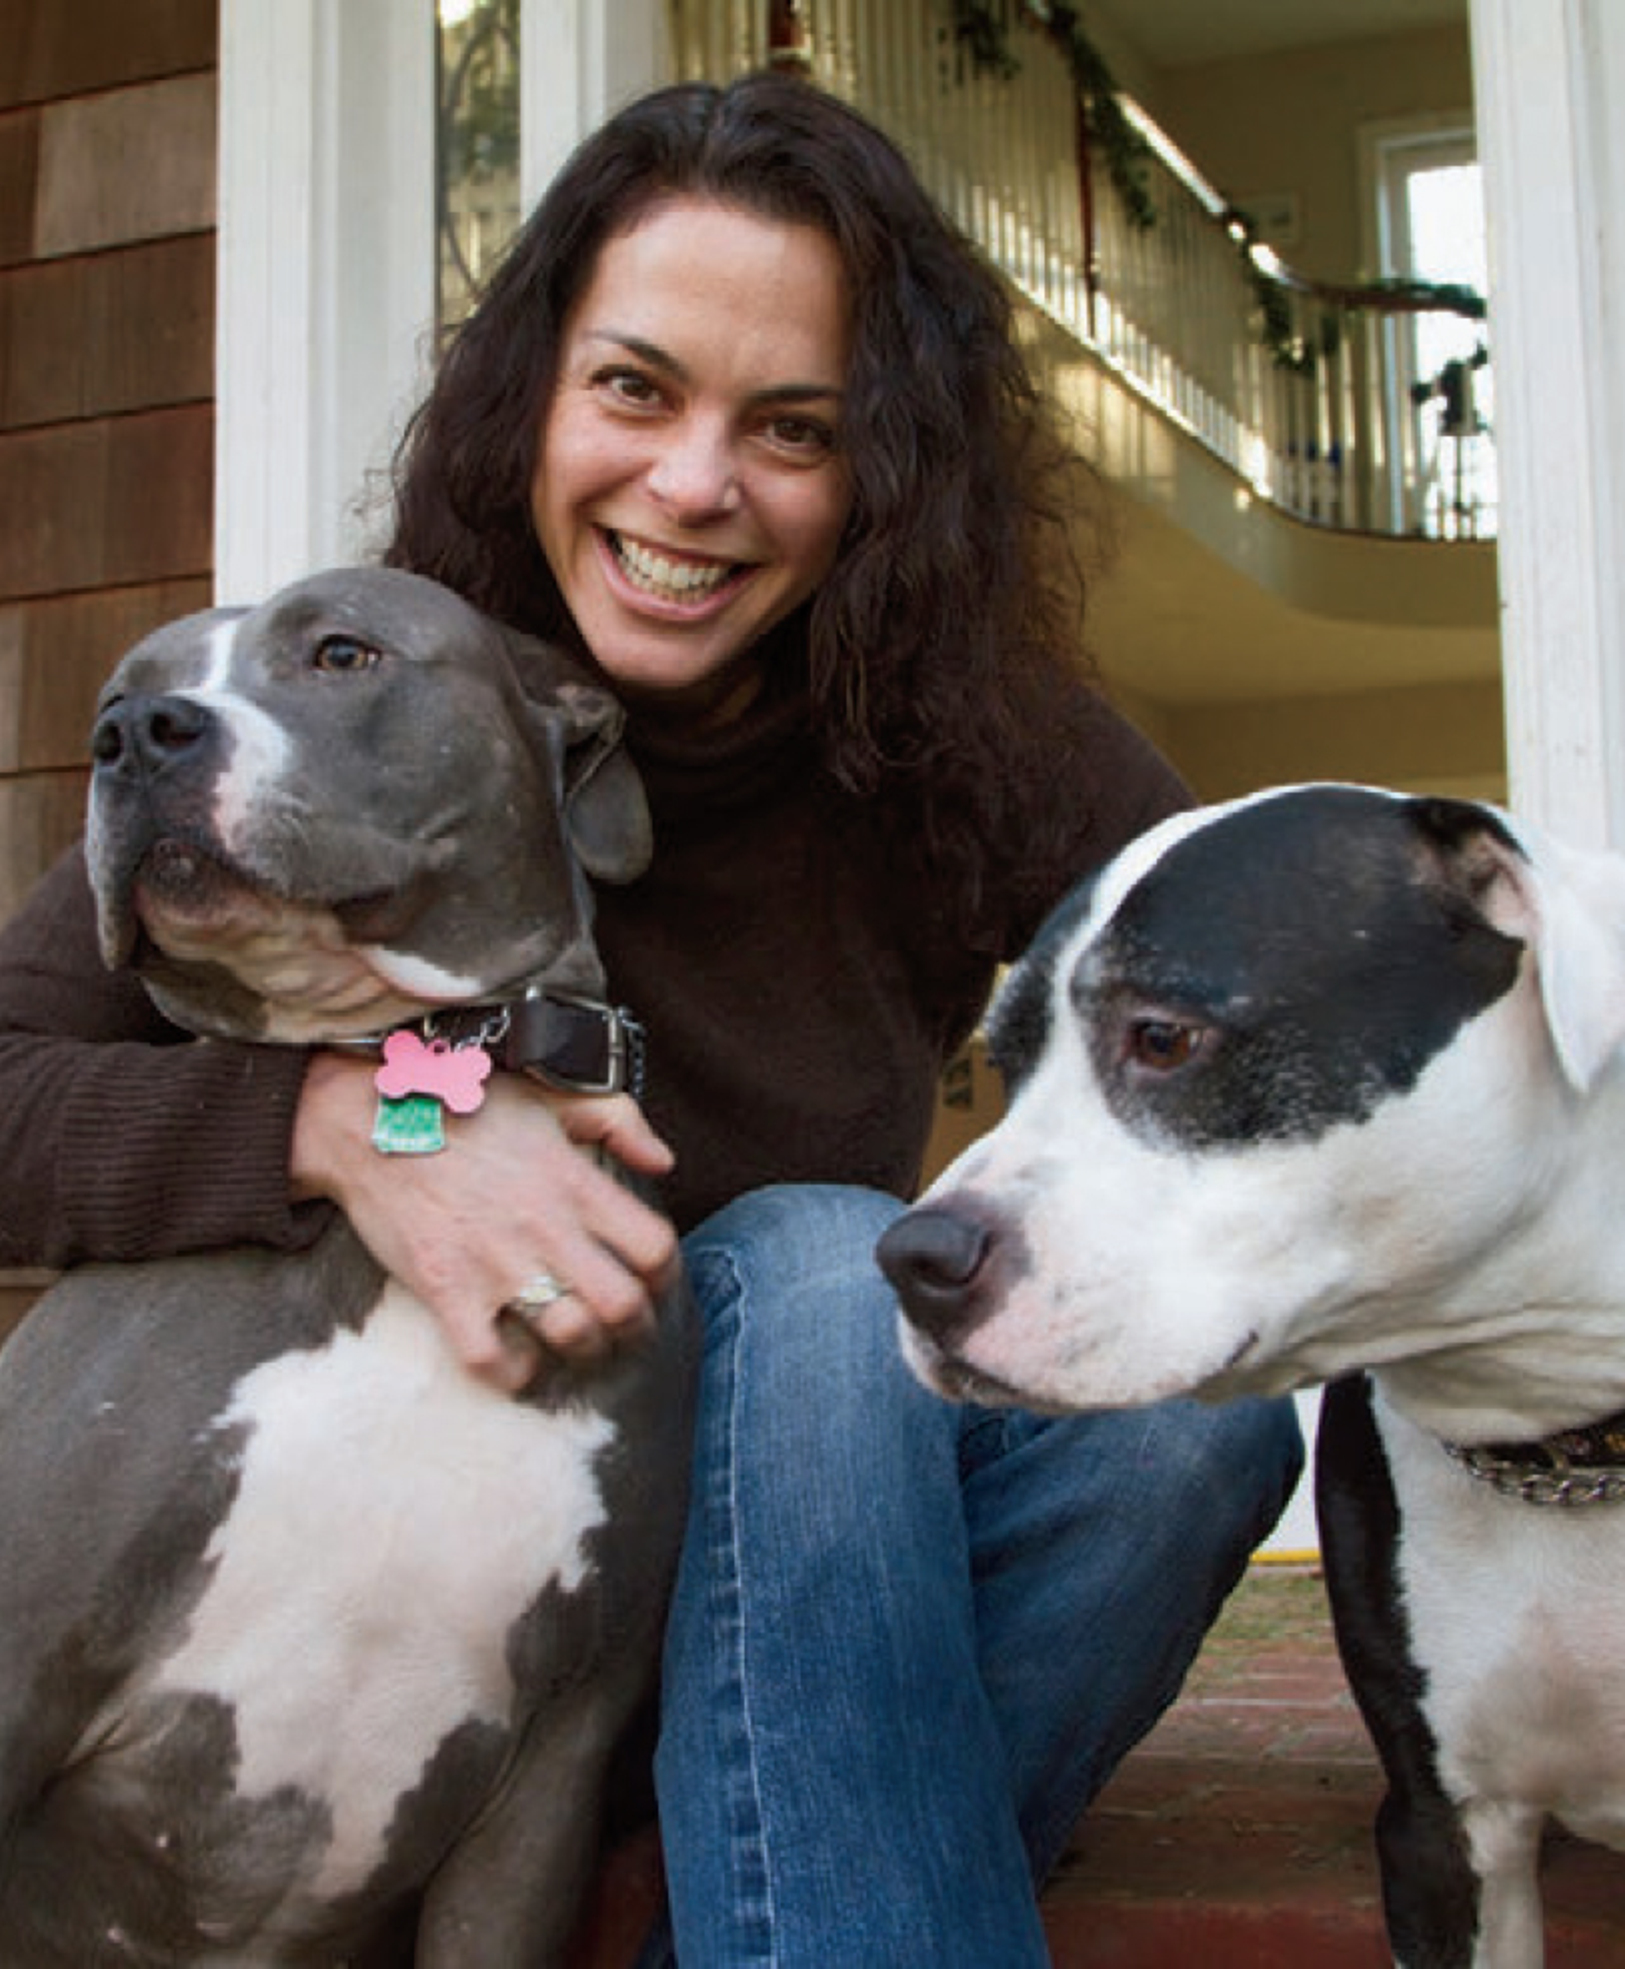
[0,849,331,1266]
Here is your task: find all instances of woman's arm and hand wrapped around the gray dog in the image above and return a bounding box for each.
[0,853,676,1386]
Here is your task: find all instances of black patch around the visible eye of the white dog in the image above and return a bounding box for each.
[1068,788,1523,1148]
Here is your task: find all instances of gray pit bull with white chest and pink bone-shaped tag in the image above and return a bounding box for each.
[0,569,693,1969]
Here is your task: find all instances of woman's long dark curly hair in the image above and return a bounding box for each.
[386,73,1101,923]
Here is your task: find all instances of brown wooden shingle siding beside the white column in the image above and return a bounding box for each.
[0,0,219,1335]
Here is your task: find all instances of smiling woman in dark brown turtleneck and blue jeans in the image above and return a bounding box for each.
[0,77,1300,1969]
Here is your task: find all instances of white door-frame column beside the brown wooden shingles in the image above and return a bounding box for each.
[215,0,435,601]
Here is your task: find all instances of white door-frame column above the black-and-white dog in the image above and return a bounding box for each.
[1471,0,1625,847]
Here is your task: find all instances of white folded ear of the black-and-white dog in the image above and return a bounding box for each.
[1507,821,1625,1093]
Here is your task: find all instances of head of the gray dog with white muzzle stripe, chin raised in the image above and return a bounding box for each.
[87,567,650,1044]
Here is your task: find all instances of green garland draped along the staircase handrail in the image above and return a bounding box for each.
[953,0,1487,376]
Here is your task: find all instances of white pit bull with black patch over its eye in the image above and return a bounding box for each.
[880,786,1625,1969]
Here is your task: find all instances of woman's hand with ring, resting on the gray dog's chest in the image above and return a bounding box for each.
[293,1053,678,1390]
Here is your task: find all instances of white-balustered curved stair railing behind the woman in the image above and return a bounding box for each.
[672,0,1495,540]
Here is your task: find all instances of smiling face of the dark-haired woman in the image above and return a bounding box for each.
[530,197,851,715]
